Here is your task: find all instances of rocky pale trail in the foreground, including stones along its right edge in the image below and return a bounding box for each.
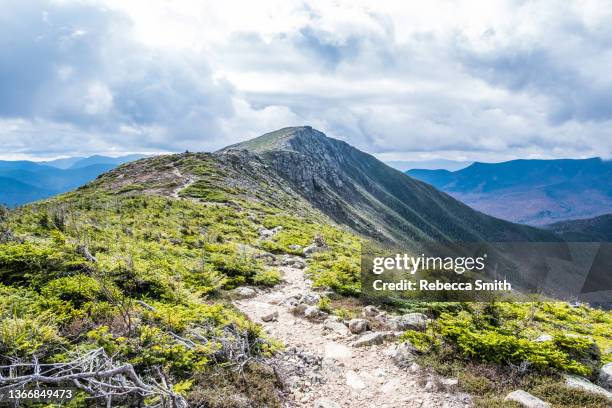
[234,256,471,408]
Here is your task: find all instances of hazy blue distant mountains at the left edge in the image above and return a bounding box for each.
[0,155,145,207]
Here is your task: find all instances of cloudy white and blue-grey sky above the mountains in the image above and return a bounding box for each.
[0,0,612,161]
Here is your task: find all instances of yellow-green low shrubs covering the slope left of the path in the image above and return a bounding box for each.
[0,181,357,406]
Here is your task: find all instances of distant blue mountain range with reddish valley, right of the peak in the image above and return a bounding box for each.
[406,158,612,225]
